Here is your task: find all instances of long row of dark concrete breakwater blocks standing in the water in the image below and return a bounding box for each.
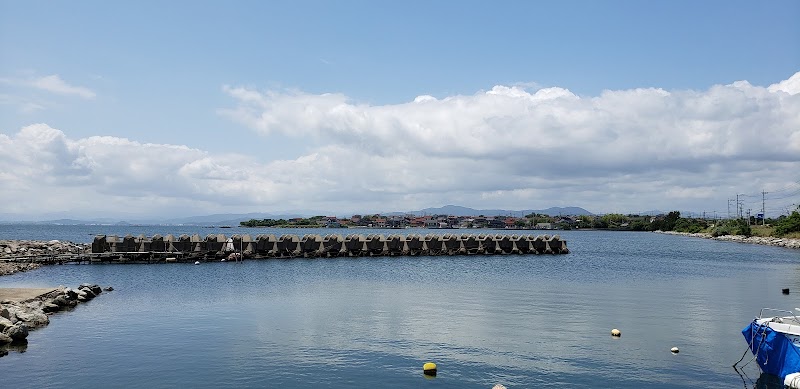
[88,234,569,262]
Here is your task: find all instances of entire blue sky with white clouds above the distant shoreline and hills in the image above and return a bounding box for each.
[0,0,800,220]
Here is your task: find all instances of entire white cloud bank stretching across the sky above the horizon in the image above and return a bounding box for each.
[0,72,800,215]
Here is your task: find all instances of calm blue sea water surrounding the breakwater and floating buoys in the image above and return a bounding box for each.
[0,226,800,388]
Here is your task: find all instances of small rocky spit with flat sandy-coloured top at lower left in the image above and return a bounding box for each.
[0,284,114,357]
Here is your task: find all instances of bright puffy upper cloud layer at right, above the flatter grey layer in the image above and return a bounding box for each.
[222,73,800,170]
